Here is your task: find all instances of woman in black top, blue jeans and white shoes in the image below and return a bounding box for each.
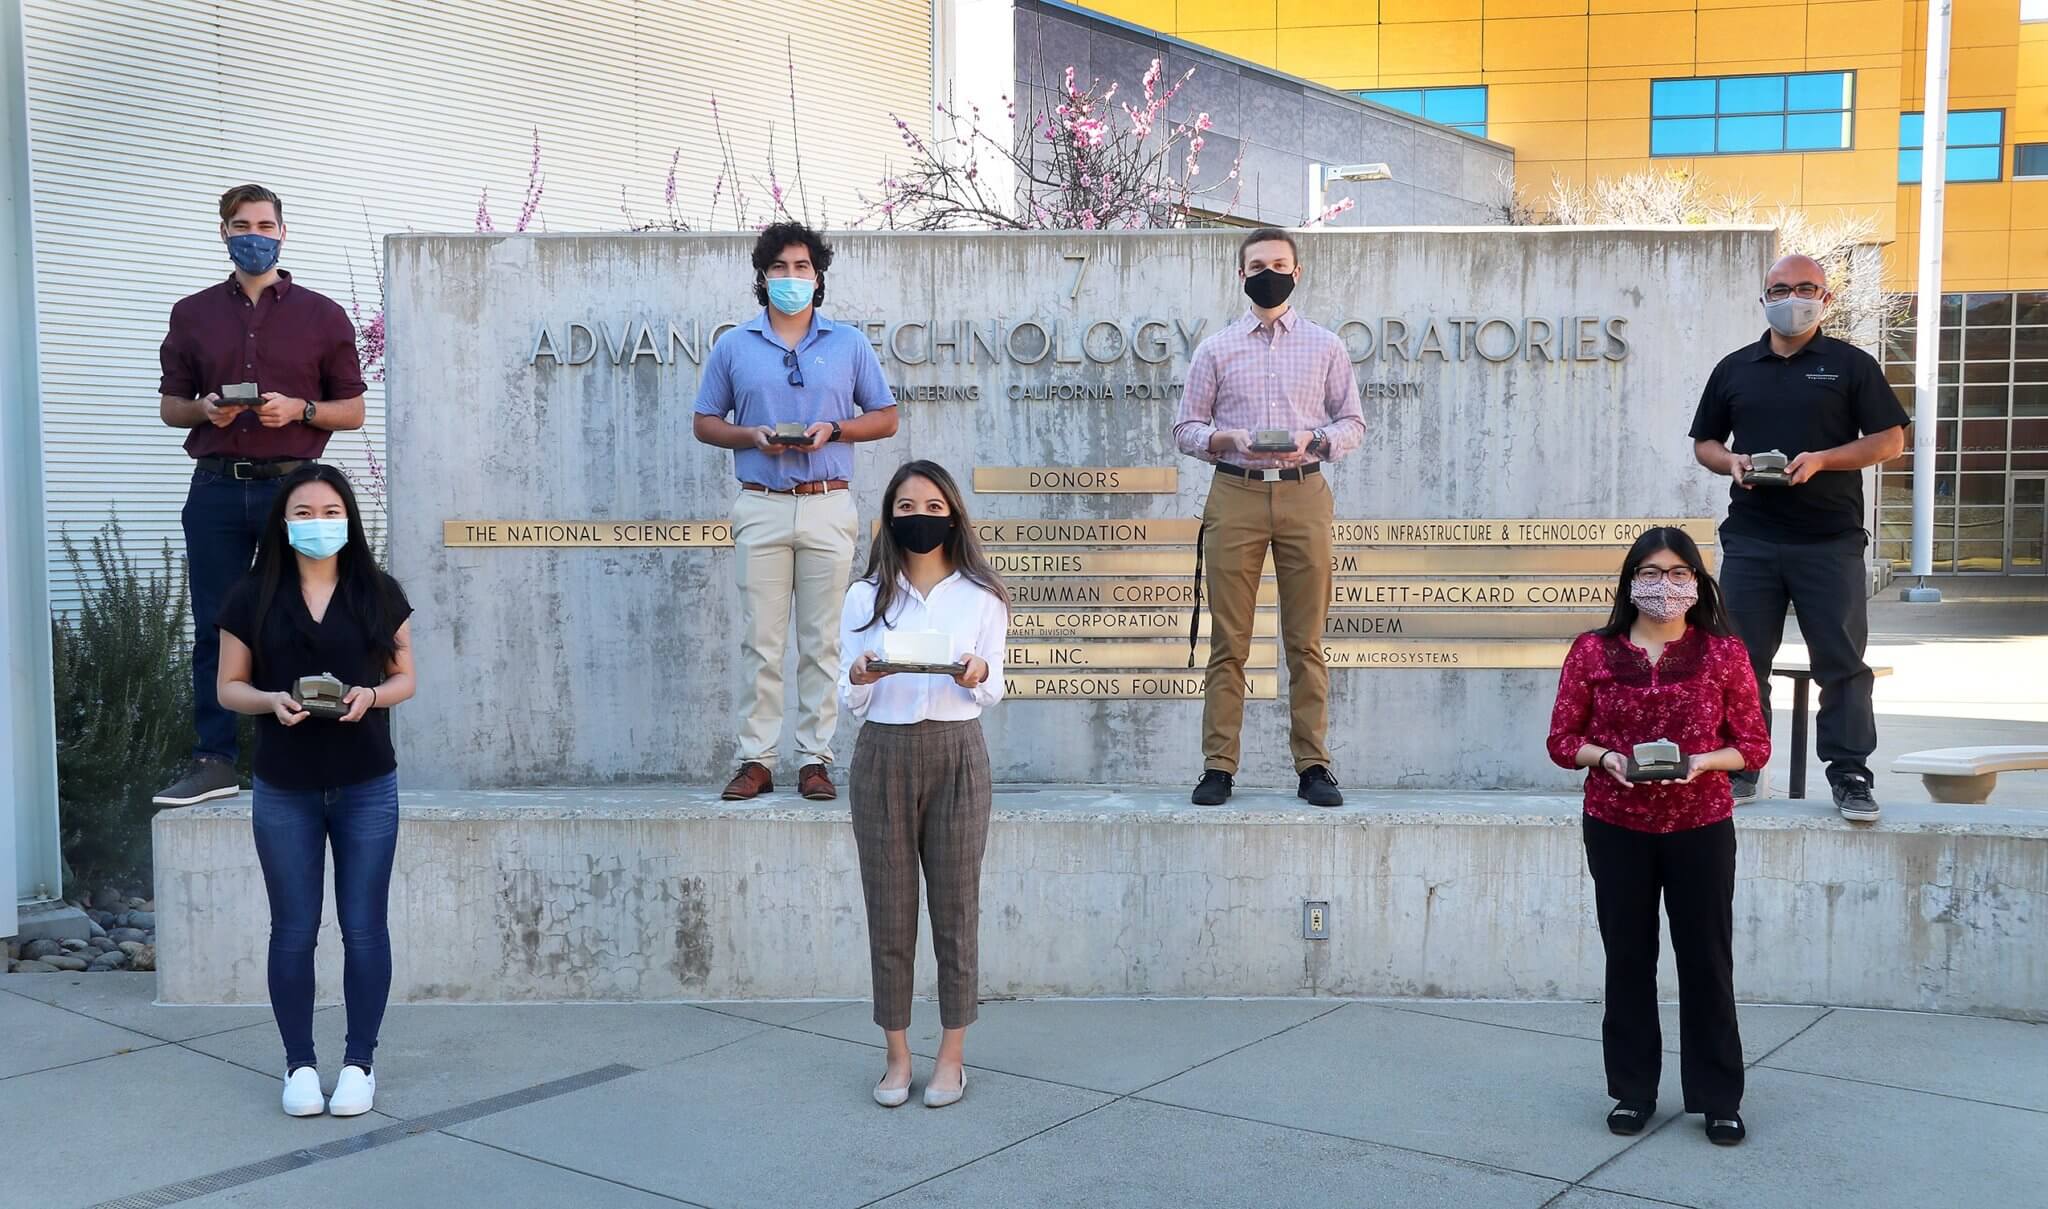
[217,465,414,1117]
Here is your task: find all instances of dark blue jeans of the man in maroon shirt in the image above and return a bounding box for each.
[180,469,279,762]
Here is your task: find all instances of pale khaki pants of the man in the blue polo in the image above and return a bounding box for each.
[733,490,854,770]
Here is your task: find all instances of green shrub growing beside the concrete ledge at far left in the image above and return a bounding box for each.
[51,520,193,885]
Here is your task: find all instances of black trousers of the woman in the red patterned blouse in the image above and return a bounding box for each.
[1585,818,1743,1113]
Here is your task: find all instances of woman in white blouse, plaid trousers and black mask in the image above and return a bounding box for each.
[840,461,1010,1109]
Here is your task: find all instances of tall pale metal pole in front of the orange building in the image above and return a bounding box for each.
[1898,0,1952,605]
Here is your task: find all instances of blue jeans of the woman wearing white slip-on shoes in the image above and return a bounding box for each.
[252,773,397,1070]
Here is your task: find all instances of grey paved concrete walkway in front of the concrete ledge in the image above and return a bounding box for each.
[0,973,2048,1209]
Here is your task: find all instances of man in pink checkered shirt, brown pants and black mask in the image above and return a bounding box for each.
[1174,227,1366,805]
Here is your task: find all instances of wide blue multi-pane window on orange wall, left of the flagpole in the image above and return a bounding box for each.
[1651,72,1855,156]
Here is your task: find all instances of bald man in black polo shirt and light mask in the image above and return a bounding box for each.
[1692,256,1911,822]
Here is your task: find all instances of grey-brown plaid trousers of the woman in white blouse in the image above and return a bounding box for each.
[848,719,993,1031]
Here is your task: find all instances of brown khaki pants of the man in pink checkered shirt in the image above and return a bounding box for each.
[1202,471,1335,775]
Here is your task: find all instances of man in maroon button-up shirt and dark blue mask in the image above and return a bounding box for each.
[156,184,365,805]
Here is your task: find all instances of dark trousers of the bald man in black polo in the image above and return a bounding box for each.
[1720,531,1878,781]
